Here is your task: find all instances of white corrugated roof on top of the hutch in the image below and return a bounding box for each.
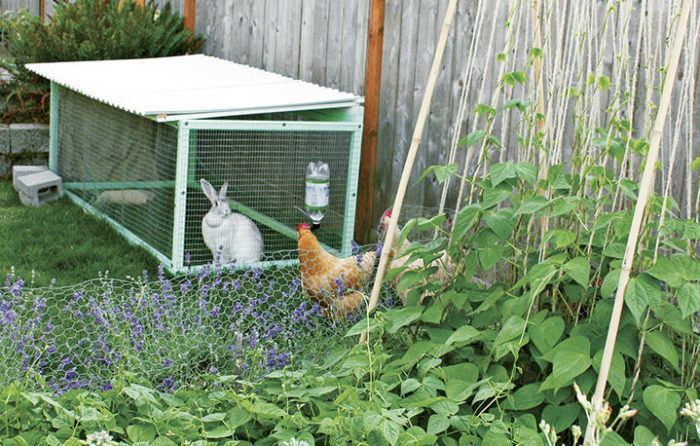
[26,55,361,120]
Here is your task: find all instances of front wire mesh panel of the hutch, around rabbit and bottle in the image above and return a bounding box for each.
[184,125,358,265]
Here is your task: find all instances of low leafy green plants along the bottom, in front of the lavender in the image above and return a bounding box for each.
[0,330,700,446]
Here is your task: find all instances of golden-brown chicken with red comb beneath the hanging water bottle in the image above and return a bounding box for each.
[297,223,377,320]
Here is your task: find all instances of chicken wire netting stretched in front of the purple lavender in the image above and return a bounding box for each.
[0,253,400,394]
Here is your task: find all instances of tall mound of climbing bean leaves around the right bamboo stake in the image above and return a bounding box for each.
[388,127,700,445]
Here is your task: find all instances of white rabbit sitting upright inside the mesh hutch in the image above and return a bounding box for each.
[199,178,263,265]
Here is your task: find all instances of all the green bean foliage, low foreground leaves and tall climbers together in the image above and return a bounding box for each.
[0,151,700,446]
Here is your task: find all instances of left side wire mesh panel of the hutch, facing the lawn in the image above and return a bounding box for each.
[57,88,177,266]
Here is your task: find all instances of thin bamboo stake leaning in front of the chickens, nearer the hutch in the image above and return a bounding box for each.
[360,0,457,343]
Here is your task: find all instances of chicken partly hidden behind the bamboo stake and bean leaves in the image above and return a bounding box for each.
[379,211,455,305]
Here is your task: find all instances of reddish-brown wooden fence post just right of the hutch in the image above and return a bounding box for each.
[355,0,386,243]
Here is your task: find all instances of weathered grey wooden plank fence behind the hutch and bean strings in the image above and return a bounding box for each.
[2,0,700,237]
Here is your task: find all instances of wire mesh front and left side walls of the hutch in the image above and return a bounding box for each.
[53,86,361,271]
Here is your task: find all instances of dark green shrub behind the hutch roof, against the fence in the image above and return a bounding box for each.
[0,0,202,122]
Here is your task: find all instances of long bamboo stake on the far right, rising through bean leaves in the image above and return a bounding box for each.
[586,0,692,442]
